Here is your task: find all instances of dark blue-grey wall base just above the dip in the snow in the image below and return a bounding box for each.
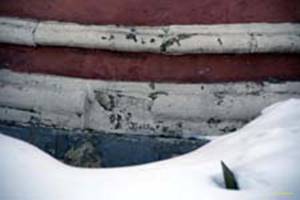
[0,123,208,167]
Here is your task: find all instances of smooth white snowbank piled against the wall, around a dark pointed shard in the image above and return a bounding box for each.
[0,99,300,200]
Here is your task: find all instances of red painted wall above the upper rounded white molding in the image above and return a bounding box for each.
[0,0,300,25]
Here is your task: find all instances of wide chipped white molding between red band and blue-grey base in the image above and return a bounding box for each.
[0,70,300,137]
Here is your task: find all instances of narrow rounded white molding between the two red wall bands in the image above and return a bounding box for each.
[0,17,300,55]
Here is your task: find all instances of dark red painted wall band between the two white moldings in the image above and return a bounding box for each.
[0,45,300,83]
